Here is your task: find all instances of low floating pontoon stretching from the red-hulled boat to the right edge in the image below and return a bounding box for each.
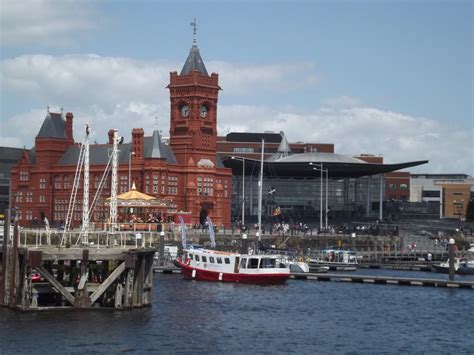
[291,273,474,289]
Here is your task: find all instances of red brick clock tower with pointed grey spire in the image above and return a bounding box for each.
[168,23,220,165]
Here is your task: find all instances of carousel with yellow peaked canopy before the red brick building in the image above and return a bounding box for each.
[107,183,176,231]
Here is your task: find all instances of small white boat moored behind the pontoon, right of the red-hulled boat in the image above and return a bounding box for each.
[309,249,358,271]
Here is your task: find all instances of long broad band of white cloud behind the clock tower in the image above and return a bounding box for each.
[0,55,474,174]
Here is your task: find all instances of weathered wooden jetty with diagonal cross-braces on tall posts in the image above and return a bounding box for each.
[0,221,156,310]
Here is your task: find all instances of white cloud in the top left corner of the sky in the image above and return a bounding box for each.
[0,0,102,47]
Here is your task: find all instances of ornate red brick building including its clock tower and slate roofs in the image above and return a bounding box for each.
[11,39,232,226]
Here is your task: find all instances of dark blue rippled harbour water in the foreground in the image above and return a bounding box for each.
[0,270,474,354]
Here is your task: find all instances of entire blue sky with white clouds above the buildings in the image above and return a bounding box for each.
[0,0,474,176]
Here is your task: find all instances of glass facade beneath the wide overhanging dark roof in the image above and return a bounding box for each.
[232,175,383,221]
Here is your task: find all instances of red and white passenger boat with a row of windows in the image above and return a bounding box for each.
[178,249,290,285]
